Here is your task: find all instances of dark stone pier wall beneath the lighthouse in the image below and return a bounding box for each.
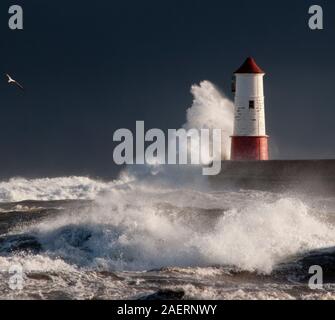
[210,160,335,195]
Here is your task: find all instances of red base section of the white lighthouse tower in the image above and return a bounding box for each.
[231,136,269,161]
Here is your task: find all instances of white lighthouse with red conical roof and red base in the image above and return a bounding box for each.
[231,57,269,161]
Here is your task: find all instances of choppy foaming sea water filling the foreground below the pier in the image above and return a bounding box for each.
[0,171,335,299]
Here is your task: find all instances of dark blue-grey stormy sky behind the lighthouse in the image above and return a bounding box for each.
[0,0,335,178]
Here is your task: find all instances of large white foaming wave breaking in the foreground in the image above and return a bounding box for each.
[17,176,335,273]
